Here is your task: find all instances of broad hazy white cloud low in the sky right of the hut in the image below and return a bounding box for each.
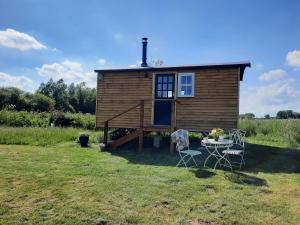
[240,79,300,116]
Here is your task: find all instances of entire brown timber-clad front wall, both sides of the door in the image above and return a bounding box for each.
[96,68,240,131]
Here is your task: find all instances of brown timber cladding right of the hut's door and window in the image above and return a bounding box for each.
[176,68,240,131]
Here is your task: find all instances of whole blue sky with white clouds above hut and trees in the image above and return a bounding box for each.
[0,0,300,116]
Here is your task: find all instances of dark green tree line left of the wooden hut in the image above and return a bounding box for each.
[0,79,96,114]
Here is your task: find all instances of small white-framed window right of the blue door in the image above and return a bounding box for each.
[178,73,195,97]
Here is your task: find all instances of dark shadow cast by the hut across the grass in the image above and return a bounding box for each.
[110,143,300,174]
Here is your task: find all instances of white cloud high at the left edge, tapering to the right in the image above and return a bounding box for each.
[0,29,47,51]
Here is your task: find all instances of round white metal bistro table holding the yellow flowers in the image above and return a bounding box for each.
[202,138,233,170]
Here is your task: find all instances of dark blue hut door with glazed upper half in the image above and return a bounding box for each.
[154,73,175,126]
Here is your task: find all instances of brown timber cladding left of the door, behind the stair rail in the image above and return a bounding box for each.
[96,72,152,128]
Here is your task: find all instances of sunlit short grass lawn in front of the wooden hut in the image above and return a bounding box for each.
[0,139,300,225]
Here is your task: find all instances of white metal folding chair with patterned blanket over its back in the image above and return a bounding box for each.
[171,129,202,168]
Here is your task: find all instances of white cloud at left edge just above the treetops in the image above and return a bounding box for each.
[0,72,37,92]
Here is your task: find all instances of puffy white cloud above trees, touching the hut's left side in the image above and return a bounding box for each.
[36,60,96,87]
